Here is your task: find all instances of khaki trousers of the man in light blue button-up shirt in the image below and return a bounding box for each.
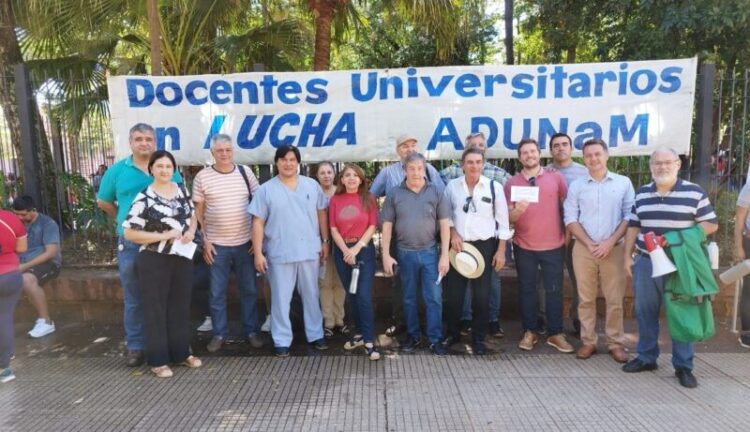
[573,242,625,349]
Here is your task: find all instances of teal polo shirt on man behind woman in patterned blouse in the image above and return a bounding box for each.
[96,156,182,235]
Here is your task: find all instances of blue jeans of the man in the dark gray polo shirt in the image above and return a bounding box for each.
[397,246,443,343]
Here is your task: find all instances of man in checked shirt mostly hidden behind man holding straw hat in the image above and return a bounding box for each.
[440,132,511,337]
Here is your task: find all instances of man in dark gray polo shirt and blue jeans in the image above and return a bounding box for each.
[383,153,451,355]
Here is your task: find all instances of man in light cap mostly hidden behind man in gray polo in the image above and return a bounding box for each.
[370,134,445,336]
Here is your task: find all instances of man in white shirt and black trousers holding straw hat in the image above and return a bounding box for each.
[444,147,510,355]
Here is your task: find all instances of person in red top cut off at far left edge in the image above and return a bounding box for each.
[0,210,27,382]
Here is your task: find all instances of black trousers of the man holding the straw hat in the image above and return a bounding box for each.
[443,238,497,342]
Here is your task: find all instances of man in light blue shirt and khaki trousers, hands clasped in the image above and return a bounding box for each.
[564,139,635,363]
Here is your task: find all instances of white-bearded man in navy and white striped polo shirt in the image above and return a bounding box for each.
[622,149,719,388]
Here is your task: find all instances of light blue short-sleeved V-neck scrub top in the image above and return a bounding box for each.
[247,175,328,264]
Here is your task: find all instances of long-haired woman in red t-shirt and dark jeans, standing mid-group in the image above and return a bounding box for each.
[328,164,380,360]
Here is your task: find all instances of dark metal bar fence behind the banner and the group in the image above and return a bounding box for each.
[0,65,750,265]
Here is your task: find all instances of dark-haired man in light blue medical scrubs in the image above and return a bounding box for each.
[247,146,328,357]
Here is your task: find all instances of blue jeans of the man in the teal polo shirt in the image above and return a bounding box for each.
[117,236,144,351]
